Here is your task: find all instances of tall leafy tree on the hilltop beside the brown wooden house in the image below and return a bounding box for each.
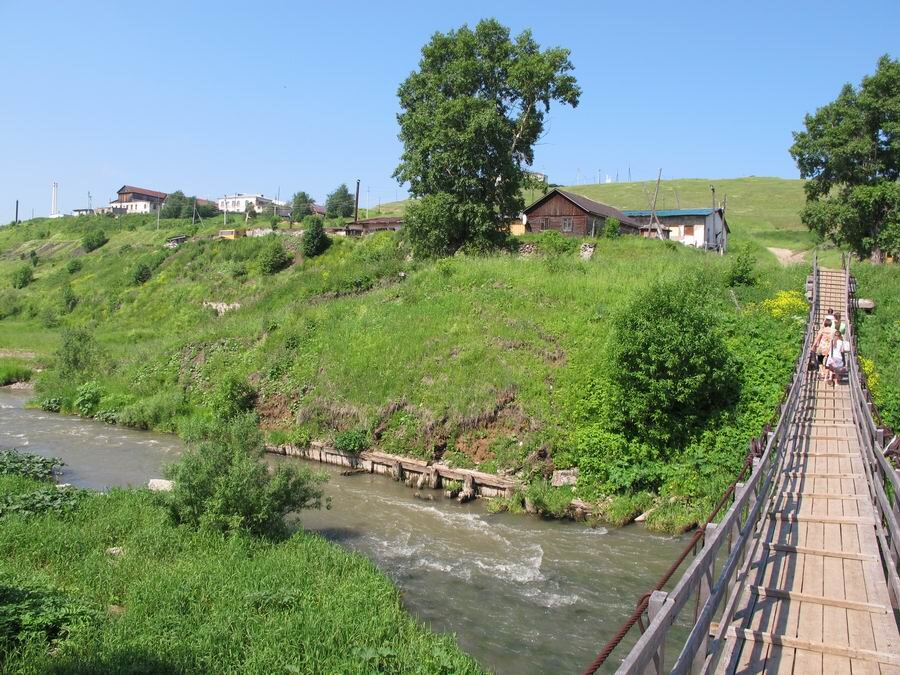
[394,19,581,255]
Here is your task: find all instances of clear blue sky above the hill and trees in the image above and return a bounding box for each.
[0,0,900,223]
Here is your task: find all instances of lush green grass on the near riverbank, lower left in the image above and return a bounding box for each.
[0,476,480,673]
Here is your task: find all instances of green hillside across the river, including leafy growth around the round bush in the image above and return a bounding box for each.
[0,216,806,530]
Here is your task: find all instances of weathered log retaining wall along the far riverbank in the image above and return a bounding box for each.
[266,442,521,497]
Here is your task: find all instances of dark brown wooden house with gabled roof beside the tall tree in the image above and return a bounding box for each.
[522,188,641,237]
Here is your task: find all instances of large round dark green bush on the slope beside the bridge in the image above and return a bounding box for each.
[606,279,739,447]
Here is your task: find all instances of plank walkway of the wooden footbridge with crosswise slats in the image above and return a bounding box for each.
[718,270,900,674]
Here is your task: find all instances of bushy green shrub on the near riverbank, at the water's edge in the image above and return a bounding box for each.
[166,415,325,537]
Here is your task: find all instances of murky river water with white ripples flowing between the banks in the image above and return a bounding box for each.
[0,390,683,674]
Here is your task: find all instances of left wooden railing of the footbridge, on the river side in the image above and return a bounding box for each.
[585,254,819,675]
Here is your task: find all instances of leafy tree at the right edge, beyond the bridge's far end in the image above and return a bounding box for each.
[791,55,900,262]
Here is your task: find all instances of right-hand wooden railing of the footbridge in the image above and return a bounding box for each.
[844,256,900,609]
